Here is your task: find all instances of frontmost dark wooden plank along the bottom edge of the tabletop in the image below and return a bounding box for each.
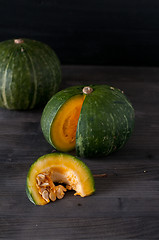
[0,217,159,240]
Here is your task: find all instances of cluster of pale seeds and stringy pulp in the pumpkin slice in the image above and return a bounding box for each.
[36,173,72,202]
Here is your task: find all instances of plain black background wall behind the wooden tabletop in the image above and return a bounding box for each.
[0,0,159,66]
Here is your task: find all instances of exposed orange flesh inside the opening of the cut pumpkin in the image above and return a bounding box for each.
[51,94,86,152]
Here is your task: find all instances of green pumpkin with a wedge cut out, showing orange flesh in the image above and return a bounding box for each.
[41,85,134,157]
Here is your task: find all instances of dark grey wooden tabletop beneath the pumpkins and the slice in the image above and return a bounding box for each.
[0,66,159,240]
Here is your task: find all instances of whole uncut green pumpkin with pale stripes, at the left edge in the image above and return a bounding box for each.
[0,38,61,110]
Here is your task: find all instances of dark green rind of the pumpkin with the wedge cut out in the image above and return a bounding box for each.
[41,85,135,158]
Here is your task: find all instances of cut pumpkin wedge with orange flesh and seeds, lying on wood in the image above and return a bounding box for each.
[26,153,95,205]
